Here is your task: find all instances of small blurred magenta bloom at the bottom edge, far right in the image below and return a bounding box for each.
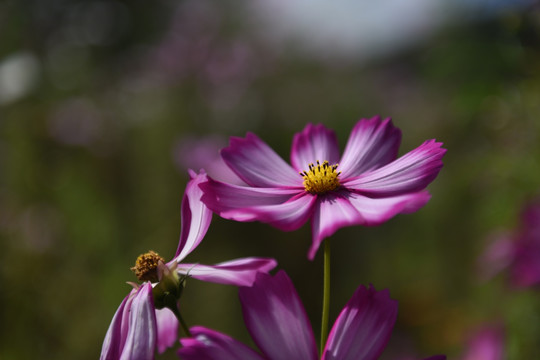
[462,326,504,360]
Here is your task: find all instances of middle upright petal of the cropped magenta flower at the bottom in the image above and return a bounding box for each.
[239,271,318,360]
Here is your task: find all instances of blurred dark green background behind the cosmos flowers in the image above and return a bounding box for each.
[0,0,540,360]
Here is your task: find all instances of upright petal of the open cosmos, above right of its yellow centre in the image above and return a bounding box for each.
[339,116,401,178]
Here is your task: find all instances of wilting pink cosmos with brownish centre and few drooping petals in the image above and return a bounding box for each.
[100,172,276,360]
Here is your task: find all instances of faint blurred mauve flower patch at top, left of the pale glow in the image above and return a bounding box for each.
[143,0,274,115]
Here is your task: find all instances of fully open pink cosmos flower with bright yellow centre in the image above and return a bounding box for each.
[201,117,446,259]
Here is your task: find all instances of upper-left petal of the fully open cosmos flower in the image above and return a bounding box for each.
[221,133,302,187]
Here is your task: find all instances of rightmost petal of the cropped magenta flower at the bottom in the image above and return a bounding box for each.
[322,285,398,360]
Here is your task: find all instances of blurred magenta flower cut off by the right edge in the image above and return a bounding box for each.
[478,199,540,288]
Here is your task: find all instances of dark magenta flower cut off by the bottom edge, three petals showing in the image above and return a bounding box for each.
[178,271,446,360]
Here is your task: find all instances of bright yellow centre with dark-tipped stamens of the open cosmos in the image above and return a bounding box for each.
[300,160,341,194]
